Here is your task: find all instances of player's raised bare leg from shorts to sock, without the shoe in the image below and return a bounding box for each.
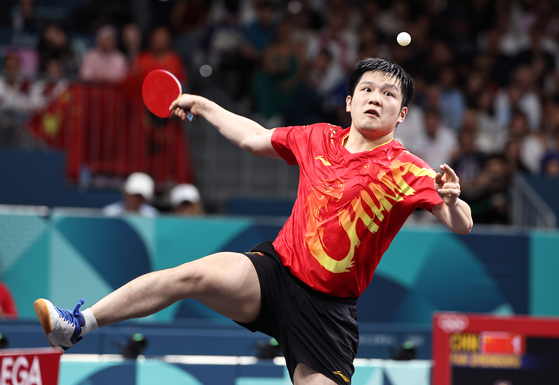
[91,253,260,327]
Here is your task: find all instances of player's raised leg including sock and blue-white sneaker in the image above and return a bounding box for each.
[34,253,260,350]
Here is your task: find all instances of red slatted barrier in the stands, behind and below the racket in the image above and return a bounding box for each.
[27,83,192,185]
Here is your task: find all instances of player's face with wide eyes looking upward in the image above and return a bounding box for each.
[346,72,408,139]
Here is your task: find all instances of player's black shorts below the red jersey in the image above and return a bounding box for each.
[238,242,359,385]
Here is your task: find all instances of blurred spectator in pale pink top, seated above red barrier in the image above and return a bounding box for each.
[80,25,128,83]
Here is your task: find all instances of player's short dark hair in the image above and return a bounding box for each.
[347,58,414,108]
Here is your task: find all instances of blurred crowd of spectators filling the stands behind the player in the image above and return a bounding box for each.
[0,0,559,223]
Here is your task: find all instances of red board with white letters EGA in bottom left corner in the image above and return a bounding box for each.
[0,348,63,385]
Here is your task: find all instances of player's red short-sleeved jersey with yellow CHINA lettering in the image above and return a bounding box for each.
[272,123,443,297]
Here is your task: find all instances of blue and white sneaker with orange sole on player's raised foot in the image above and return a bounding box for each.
[33,298,85,350]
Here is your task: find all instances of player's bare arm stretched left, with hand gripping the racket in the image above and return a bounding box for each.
[169,94,280,159]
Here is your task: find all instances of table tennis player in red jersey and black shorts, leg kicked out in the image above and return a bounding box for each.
[35,58,473,385]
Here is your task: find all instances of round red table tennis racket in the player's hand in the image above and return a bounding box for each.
[142,70,196,122]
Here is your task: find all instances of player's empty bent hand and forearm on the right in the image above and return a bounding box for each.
[431,164,474,234]
